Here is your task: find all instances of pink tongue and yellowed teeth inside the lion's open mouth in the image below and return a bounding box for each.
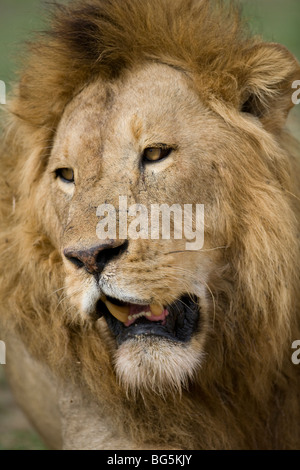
[101,296,169,326]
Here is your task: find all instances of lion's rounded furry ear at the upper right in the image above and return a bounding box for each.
[240,43,300,130]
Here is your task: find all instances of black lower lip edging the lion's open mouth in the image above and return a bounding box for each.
[97,296,199,345]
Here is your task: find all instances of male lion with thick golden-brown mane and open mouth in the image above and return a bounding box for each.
[0,0,300,449]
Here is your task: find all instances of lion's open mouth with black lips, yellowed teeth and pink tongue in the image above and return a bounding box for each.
[97,295,200,345]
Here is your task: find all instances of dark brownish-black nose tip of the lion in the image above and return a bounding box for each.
[63,240,128,274]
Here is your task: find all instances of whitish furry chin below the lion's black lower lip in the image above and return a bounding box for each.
[114,336,203,396]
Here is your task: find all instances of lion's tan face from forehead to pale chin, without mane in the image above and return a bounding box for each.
[41,64,260,390]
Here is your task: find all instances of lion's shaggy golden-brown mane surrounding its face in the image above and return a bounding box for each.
[0,0,300,449]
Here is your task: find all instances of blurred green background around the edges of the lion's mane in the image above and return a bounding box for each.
[0,0,300,450]
